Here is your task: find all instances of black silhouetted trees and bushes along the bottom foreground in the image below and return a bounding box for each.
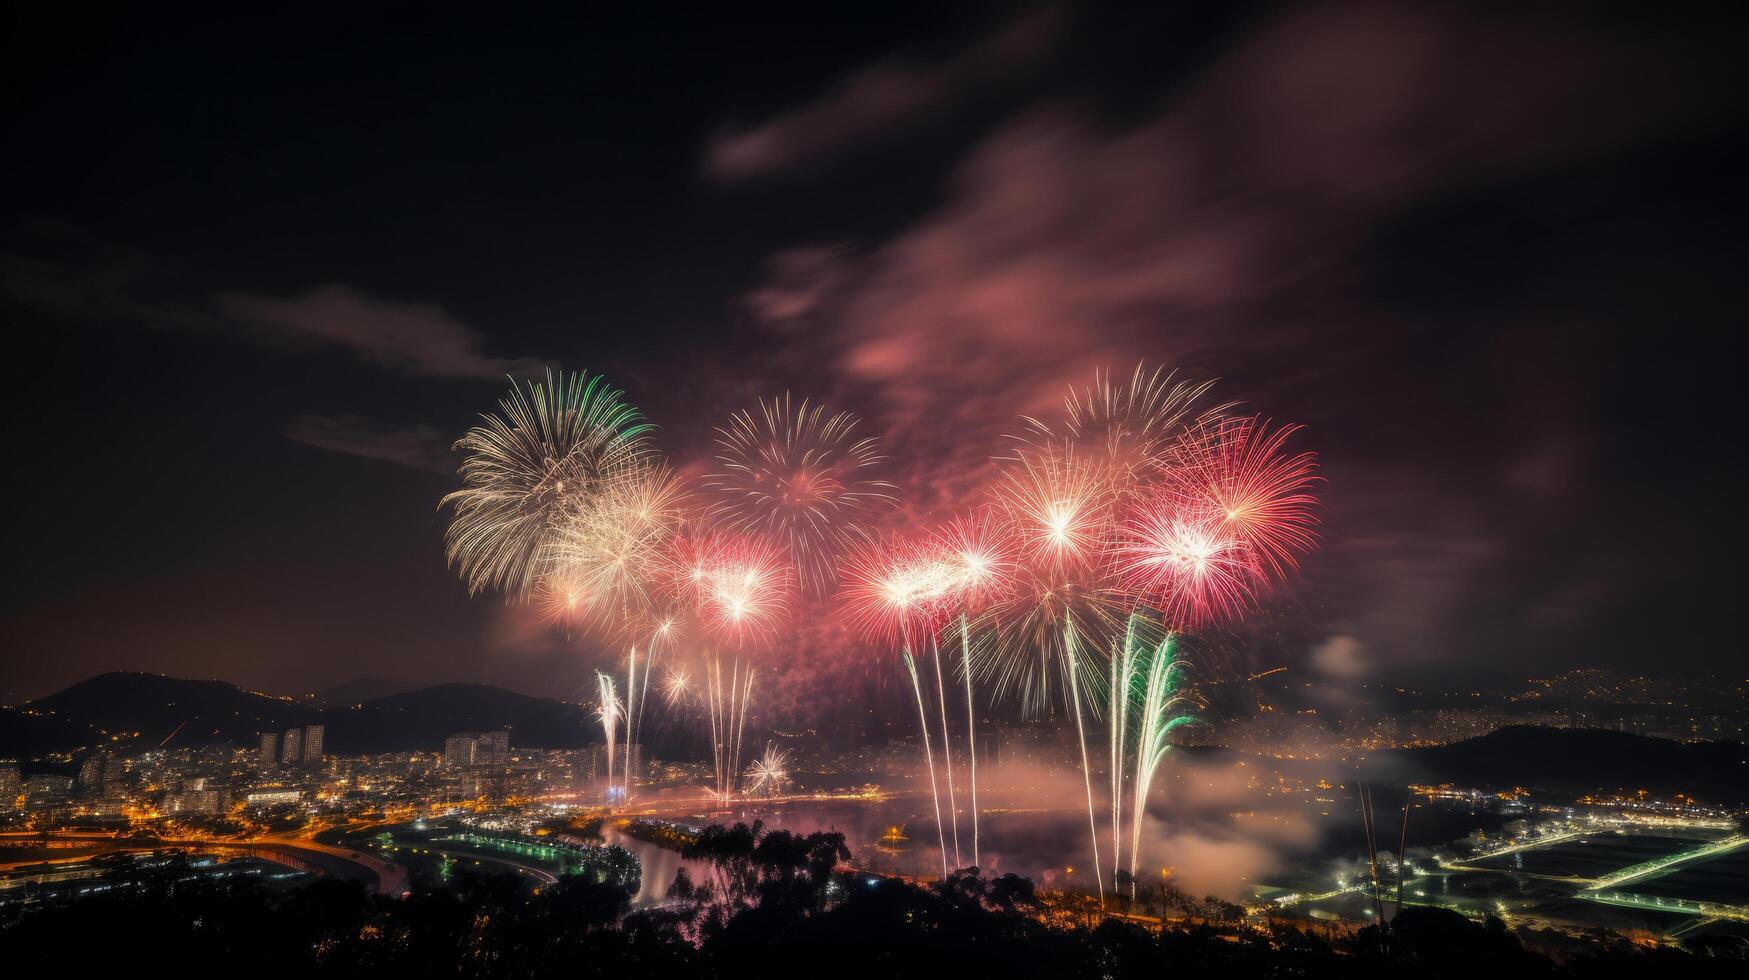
[0,826,1744,980]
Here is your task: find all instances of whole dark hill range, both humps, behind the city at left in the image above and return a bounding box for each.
[0,674,600,758]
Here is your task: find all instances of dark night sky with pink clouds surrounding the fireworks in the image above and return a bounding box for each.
[0,2,1749,704]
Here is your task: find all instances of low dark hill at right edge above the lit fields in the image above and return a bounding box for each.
[1387,726,1749,803]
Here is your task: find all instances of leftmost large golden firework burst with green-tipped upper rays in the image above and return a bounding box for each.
[439,371,651,597]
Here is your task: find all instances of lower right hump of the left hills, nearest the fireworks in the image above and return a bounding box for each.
[322,684,600,754]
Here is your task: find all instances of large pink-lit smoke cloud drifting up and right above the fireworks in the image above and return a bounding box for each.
[731,4,1718,665]
